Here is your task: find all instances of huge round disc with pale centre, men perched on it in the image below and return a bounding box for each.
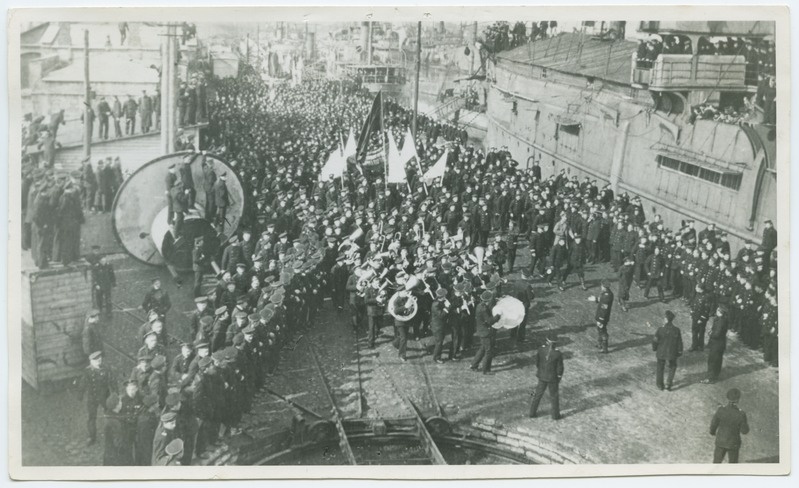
[111,151,246,271]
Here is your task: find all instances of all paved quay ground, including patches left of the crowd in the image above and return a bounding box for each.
[21,252,779,465]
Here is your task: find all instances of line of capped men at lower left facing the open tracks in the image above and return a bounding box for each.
[78,206,332,465]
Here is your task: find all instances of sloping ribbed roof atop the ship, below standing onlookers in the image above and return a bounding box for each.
[497,33,637,85]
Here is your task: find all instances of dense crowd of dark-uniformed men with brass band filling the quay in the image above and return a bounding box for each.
[72,73,777,464]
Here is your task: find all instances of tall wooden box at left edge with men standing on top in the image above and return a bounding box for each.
[20,264,92,389]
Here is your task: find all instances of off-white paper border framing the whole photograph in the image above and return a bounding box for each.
[6,5,792,480]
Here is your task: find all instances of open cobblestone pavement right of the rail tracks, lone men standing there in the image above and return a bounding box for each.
[362,263,779,463]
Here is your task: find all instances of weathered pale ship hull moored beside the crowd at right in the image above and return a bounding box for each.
[486,57,776,247]
